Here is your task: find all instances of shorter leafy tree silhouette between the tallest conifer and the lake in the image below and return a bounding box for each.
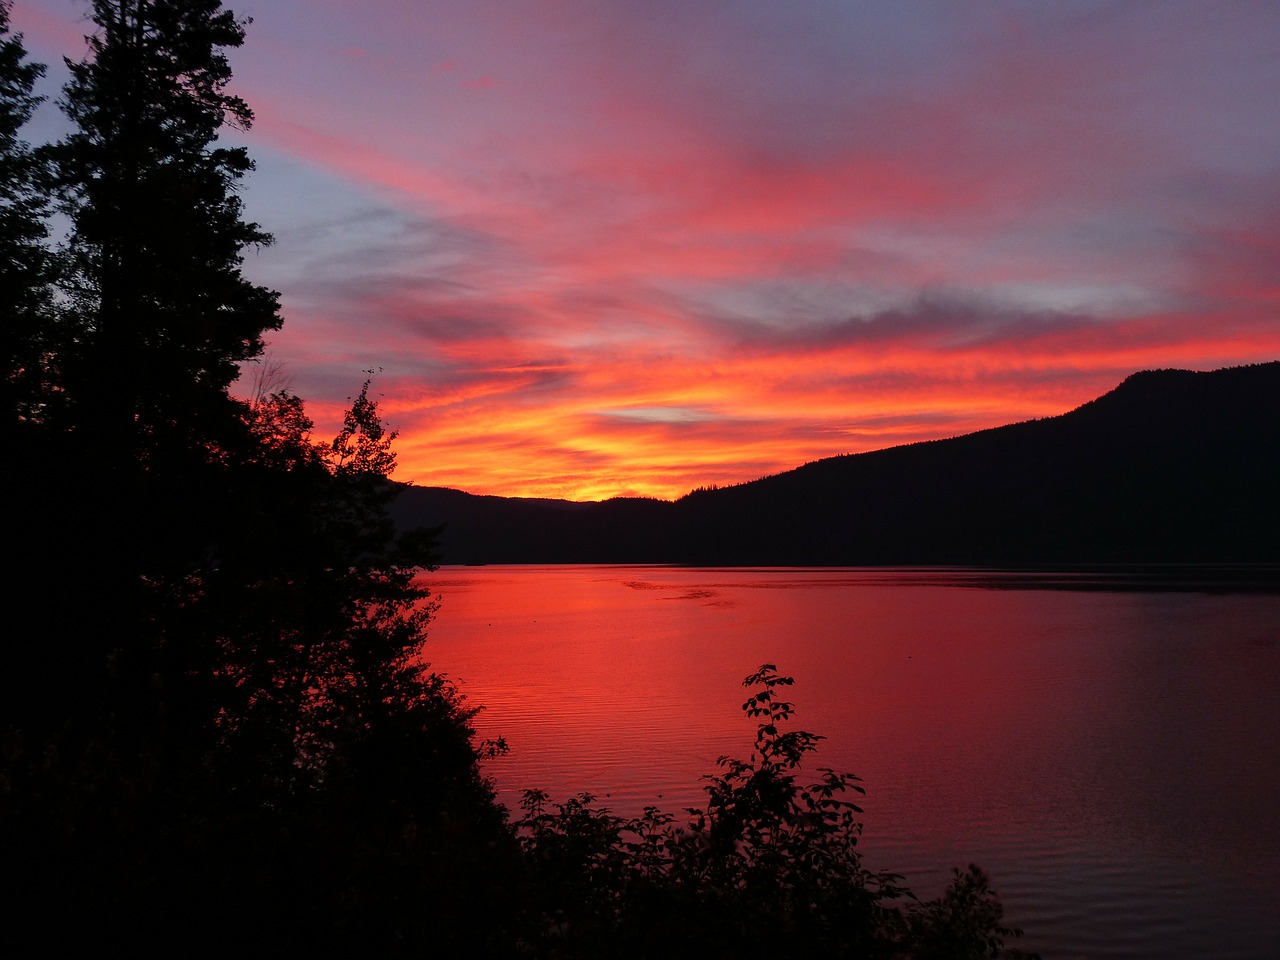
[172,383,507,950]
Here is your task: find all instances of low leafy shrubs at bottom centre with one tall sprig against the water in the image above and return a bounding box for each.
[516,664,1039,960]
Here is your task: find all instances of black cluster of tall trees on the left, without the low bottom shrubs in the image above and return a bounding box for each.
[0,0,509,950]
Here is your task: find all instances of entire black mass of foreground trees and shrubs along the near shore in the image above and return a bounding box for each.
[0,0,1034,957]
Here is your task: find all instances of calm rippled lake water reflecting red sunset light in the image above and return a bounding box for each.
[429,567,1280,960]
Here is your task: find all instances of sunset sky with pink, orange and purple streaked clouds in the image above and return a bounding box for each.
[12,0,1280,500]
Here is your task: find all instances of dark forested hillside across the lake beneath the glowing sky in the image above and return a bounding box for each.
[396,362,1280,566]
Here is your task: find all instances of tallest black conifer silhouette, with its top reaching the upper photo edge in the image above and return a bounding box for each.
[11,0,280,768]
